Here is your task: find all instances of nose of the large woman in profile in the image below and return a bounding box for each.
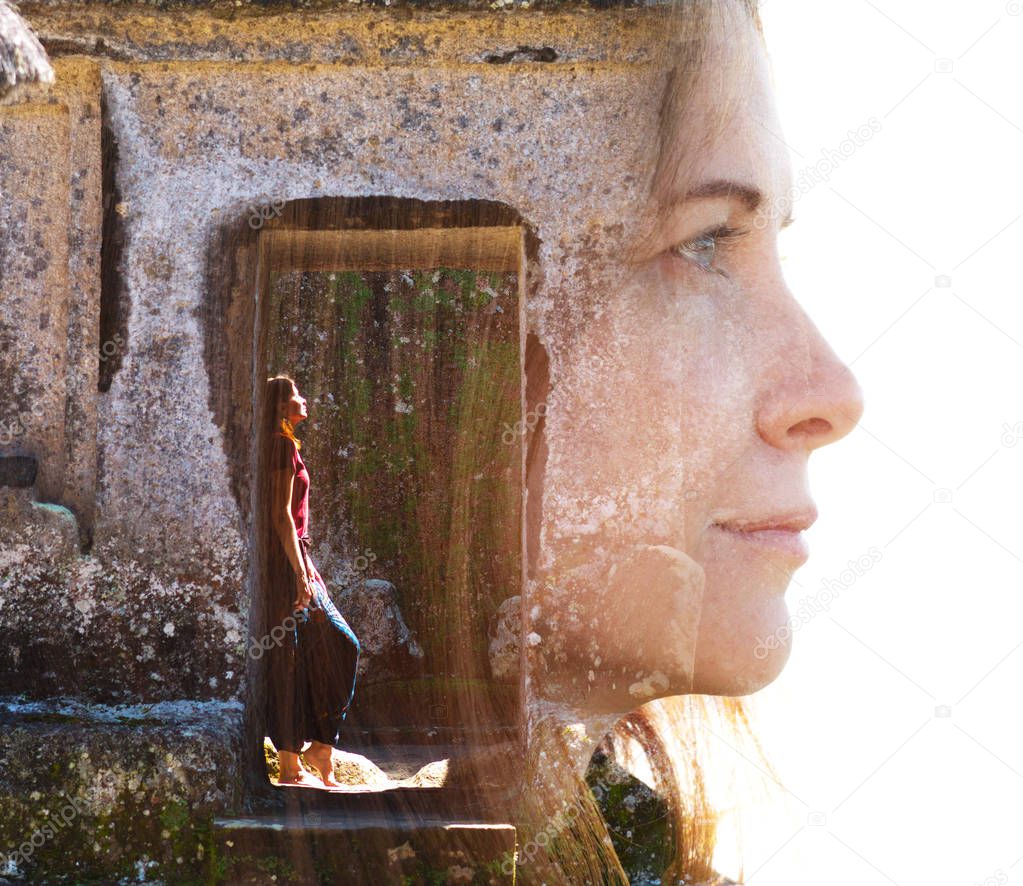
[757,309,863,452]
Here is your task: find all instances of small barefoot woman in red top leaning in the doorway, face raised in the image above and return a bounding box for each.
[262,375,360,788]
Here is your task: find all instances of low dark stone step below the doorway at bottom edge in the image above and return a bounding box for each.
[211,806,516,886]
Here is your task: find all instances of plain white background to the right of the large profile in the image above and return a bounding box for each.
[717,0,1023,886]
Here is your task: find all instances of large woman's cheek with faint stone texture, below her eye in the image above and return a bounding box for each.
[554,286,754,551]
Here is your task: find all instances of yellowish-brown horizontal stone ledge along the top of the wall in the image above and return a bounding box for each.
[21,2,663,67]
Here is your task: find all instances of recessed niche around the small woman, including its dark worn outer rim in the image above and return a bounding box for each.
[203,197,536,789]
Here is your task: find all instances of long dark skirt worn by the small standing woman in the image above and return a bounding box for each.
[266,564,360,753]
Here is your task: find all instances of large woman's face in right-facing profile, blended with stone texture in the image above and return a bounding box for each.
[548,13,862,704]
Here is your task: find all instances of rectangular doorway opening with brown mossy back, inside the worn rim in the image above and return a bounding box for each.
[252,205,525,794]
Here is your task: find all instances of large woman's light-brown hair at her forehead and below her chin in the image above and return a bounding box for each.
[520,0,779,884]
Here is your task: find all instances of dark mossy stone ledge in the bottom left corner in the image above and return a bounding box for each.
[0,699,241,883]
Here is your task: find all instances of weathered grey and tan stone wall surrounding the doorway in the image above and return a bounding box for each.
[0,3,656,875]
